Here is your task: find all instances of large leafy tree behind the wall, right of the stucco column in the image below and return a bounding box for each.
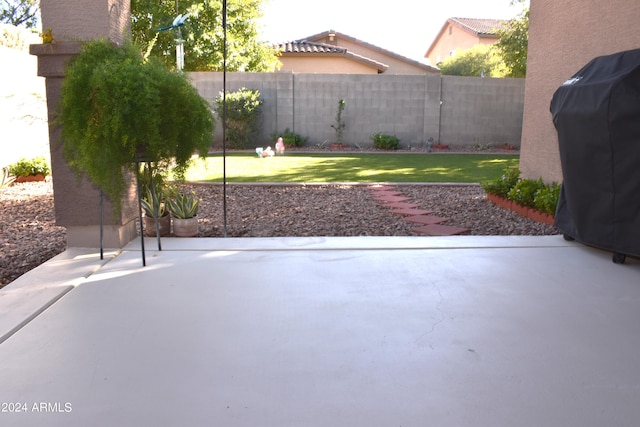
[131,0,278,72]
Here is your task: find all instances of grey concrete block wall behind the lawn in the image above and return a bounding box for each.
[189,72,524,148]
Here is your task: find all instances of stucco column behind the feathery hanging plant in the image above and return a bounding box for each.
[30,0,136,248]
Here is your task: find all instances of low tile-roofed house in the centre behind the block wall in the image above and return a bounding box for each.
[276,30,439,74]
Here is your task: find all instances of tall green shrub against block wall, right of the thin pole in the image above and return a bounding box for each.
[216,87,262,149]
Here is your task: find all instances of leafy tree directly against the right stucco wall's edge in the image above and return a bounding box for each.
[495,9,529,77]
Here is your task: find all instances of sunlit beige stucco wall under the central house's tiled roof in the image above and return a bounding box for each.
[280,54,378,74]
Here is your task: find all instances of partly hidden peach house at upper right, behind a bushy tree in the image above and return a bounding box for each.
[424,18,506,66]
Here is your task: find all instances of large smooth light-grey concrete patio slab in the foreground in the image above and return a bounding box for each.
[0,236,640,427]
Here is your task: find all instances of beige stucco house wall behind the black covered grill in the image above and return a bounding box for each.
[520,0,640,182]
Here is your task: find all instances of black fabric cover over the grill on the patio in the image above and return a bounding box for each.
[551,49,640,256]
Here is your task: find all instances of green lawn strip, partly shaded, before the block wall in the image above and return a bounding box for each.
[186,152,519,182]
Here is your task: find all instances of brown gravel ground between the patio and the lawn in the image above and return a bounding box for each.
[0,182,557,287]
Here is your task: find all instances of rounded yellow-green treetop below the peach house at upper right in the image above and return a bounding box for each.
[438,45,506,77]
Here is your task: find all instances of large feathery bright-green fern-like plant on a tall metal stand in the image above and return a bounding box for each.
[58,40,214,214]
